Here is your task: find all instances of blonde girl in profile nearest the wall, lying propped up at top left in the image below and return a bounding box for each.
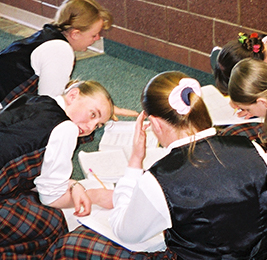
[0,0,138,119]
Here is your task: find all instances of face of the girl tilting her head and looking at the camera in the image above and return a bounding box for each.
[65,88,112,136]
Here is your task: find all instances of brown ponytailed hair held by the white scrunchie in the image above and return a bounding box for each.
[141,71,212,134]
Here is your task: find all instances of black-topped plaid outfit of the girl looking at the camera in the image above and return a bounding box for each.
[0,96,71,259]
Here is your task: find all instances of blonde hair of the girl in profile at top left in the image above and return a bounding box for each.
[53,0,113,31]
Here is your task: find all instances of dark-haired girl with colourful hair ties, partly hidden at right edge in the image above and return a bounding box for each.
[214,33,267,149]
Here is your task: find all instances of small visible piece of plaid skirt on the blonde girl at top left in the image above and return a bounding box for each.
[1,75,39,107]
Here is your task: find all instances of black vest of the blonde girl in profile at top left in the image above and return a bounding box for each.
[0,24,67,102]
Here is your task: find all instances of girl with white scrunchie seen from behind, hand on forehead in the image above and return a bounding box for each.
[51,71,267,260]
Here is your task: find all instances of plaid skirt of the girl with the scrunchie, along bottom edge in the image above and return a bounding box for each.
[47,226,179,260]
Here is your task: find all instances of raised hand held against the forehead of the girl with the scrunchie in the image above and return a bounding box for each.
[129,111,150,169]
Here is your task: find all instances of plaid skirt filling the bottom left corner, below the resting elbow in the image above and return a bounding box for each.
[0,191,68,260]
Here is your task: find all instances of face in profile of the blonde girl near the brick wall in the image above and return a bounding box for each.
[66,19,103,51]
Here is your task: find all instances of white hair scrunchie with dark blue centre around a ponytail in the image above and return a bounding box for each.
[169,78,201,115]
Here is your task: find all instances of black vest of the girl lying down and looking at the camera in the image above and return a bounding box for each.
[0,95,70,169]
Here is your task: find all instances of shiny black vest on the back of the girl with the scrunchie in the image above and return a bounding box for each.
[150,136,267,259]
